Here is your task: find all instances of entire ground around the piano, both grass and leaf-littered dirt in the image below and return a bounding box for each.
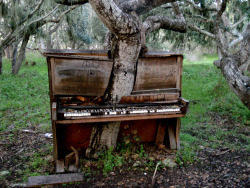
[0,51,250,187]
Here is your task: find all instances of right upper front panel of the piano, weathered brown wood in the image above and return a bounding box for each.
[133,56,180,91]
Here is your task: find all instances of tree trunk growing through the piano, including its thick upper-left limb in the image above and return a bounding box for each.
[86,0,141,158]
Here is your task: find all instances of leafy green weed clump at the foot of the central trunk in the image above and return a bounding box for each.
[99,147,124,175]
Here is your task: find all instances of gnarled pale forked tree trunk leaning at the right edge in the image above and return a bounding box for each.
[214,0,250,109]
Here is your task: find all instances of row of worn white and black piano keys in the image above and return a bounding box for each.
[62,105,181,119]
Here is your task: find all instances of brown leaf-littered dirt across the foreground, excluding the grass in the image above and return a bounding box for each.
[0,127,250,188]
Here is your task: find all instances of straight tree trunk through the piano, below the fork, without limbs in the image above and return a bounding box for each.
[86,35,141,158]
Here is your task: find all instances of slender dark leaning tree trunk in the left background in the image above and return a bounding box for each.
[12,34,30,75]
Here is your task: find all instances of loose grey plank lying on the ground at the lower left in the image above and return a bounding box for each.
[26,173,84,187]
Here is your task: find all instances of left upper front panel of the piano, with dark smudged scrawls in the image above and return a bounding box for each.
[51,58,113,96]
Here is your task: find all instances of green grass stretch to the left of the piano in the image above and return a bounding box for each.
[0,50,50,131]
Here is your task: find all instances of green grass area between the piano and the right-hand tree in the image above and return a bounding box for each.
[177,55,250,163]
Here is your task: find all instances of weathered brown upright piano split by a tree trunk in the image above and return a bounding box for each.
[43,50,189,169]
